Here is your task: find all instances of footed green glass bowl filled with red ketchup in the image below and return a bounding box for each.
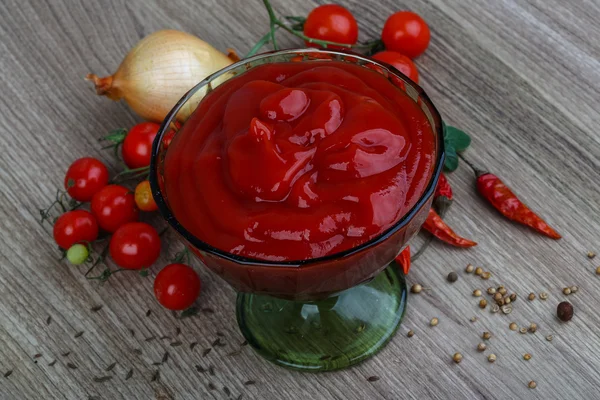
[150,49,444,371]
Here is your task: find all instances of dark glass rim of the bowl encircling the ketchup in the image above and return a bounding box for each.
[149,48,445,267]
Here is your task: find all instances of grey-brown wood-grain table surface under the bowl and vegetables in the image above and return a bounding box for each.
[0,0,600,399]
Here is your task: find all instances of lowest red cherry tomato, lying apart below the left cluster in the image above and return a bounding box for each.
[154,264,201,310]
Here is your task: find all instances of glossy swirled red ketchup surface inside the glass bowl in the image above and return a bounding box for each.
[164,61,435,261]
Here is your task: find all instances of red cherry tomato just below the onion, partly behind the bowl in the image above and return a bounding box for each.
[123,122,160,169]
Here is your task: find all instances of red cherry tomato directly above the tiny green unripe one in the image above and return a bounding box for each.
[53,210,98,250]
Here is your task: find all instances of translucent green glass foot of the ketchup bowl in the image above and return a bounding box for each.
[237,263,407,372]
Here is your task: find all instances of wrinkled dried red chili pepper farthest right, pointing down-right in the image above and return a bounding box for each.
[476,171,561,239]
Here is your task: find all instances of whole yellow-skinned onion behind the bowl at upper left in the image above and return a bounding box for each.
[86,30,232,122]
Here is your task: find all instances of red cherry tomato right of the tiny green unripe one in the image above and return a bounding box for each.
[108,222,160,269]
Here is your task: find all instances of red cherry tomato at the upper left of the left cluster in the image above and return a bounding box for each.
[65,157,108,201]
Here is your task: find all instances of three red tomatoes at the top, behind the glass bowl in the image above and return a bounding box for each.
[303,4,430,83]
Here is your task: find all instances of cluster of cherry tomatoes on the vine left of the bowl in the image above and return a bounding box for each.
[43,122,201,310]
